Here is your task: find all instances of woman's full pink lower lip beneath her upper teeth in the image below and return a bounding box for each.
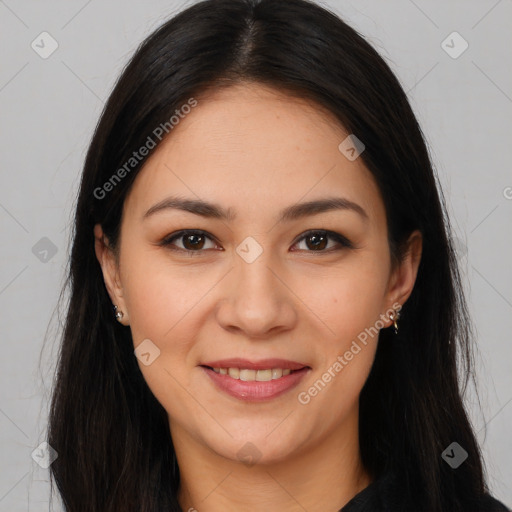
[201,366,310,402]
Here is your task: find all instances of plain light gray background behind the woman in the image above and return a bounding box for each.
[0,0,512,512]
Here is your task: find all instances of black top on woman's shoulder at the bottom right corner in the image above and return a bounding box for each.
[339,477,511,512]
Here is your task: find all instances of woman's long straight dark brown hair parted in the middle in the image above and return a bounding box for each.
[48,0,487,512]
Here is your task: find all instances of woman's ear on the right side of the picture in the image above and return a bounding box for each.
[386,230,423,324]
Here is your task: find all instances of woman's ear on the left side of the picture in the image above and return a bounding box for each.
[94,224,129,325]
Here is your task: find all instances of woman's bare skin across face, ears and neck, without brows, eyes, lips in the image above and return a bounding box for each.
[95,84,421,512]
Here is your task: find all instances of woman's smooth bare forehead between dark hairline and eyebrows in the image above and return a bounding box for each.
[121,84,383,224]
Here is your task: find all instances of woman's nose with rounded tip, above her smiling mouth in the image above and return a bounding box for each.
[217,251,298,339]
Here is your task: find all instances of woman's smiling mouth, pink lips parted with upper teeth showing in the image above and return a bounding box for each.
[201,358,311,401]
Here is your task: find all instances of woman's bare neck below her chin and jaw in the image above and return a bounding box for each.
[171,412,371,512]
